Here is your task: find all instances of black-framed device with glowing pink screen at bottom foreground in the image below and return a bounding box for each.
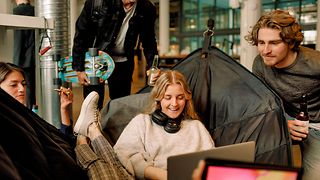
[202,158,302,180]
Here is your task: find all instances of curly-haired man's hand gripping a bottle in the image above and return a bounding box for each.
[288,119,309,141]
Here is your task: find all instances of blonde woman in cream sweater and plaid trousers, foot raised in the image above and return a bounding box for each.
[74,70,215,179]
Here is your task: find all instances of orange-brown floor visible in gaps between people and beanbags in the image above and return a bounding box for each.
[72,56,301,167]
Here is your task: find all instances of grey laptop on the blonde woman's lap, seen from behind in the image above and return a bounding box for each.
[167,141,255,180]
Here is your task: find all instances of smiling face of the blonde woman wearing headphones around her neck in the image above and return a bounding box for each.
[160,84,186,119]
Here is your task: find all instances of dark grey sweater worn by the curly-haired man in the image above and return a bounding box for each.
[252,47,320,122]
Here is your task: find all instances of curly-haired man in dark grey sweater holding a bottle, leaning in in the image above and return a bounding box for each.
[245,10,320,179]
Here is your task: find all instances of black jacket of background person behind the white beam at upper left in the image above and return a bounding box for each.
[13,3,35,68]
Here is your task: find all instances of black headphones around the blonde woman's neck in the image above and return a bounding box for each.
[151,109,181,133]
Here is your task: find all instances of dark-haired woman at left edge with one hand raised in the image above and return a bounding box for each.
[0,62,75,139]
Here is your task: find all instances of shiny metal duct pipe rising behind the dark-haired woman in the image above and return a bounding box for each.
[35,0,69,128]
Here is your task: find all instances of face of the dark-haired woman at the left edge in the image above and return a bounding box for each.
[0,71,26,105]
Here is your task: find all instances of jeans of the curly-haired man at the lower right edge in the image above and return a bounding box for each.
[302,128,320,180]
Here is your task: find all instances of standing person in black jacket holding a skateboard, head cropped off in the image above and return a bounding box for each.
[72,0,157,109]
